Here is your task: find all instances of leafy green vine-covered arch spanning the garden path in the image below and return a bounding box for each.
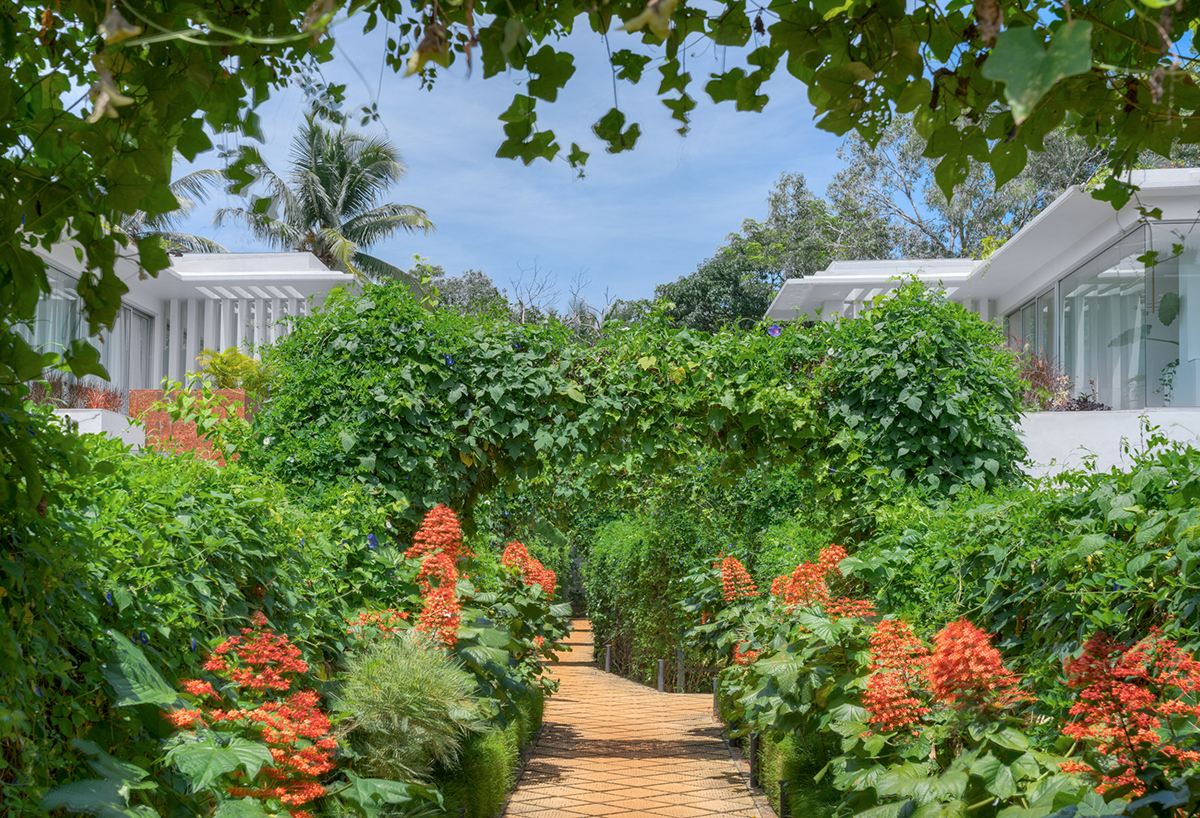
[248,282,1024,532]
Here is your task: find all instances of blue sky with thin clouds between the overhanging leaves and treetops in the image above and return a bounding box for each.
[181,19,841,303]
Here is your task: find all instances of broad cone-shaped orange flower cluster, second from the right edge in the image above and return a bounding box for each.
[929,619,1028,710]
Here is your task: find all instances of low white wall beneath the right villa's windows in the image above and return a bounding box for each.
[1021,409,1200,477]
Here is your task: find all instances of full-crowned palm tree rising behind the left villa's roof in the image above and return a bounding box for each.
[214,115,433,281]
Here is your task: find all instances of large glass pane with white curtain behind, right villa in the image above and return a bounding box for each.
[1060,229,1148,409]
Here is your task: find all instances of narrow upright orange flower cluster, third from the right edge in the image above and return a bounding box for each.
[863,619,930,735]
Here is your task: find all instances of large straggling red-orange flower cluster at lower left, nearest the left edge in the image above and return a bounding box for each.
[167,613,337,818]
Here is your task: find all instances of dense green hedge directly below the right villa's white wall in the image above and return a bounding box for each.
[847,436,1200,715]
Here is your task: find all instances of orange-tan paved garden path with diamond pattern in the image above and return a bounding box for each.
[504,619,761,818]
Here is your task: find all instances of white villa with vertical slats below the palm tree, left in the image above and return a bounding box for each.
[26,245,354,392]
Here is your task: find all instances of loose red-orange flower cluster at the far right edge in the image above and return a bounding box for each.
[1062,628,1200,795]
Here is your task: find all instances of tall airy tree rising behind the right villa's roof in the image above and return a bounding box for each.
[826,116,1108,258]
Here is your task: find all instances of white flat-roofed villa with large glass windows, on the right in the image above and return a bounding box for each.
[767,168,1200,468]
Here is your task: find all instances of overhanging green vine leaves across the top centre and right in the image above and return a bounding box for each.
[355,0,1200,209]
